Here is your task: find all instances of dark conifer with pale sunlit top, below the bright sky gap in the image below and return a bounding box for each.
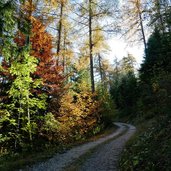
[110,54,138,117]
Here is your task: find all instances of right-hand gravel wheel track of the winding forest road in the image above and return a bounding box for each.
[79,125,135,171]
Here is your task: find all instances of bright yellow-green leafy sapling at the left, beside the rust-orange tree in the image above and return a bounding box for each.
[1,46,46,150]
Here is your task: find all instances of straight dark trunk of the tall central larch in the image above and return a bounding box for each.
[89,0,95,93]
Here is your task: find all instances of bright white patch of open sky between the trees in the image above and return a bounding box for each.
[106,37,144,67]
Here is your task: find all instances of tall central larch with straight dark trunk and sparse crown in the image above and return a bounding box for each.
[73,0,114,92]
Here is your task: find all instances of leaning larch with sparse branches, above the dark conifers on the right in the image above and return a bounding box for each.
[121,0,148,51]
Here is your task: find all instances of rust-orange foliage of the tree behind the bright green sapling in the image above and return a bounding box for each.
[15,17,64,96]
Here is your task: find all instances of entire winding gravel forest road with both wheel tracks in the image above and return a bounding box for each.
[26,123,136,171]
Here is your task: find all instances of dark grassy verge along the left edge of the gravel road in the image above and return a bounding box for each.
[0,126,116,171]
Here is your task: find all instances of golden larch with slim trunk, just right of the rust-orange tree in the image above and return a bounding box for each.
[45,0,72,71]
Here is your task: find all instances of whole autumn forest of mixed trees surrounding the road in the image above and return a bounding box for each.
[0,0,171,171]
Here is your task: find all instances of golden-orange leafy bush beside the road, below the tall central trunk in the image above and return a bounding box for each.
[58,91,100,141]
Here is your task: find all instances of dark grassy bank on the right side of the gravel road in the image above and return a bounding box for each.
[119,116,171,171]
